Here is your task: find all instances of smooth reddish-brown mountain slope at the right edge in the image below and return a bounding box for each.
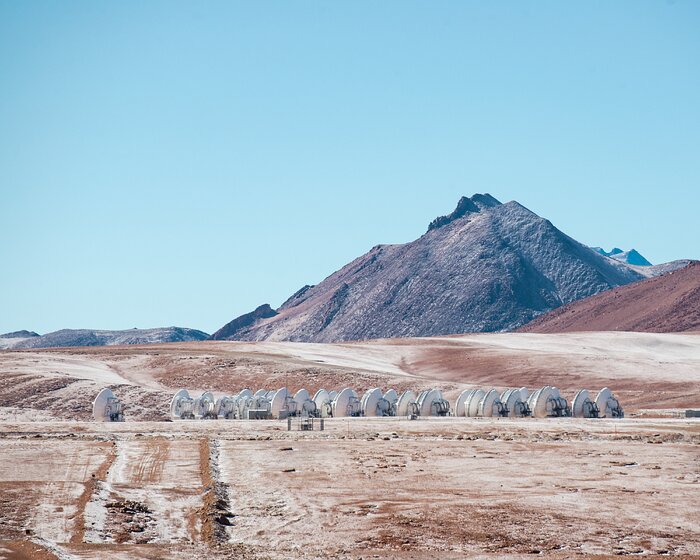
[519,261,700,333]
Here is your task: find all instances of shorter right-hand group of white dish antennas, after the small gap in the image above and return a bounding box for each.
[453,385,624,418]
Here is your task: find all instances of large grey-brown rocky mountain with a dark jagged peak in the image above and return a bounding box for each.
[215,194,644,342]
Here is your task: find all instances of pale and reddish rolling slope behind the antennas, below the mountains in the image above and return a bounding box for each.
[0,333,700,420]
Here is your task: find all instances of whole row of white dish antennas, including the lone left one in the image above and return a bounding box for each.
[92,386,624,422]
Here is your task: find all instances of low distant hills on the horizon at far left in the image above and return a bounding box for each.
[0,327,209,349]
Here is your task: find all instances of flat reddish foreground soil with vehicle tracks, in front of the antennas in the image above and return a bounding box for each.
[0,419,700,559]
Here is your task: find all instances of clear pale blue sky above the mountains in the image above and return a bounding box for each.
[0,0,700,333]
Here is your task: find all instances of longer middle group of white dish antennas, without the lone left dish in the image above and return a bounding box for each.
[170,387,450,420]
